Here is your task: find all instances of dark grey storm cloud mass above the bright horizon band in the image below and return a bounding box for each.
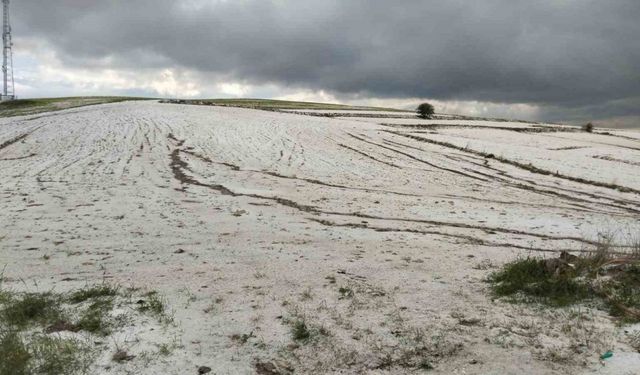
[8,0,640,115]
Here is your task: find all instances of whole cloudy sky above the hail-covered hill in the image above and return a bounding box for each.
[11,0,640,127]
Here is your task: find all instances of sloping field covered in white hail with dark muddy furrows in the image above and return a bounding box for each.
[0,102,640,374]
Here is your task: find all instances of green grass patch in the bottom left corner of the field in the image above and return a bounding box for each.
[0,283,169,375]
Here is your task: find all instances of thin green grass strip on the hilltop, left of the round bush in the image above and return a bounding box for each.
[164,99,406,112]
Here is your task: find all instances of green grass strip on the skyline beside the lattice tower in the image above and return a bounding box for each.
[0,96,148,117]
